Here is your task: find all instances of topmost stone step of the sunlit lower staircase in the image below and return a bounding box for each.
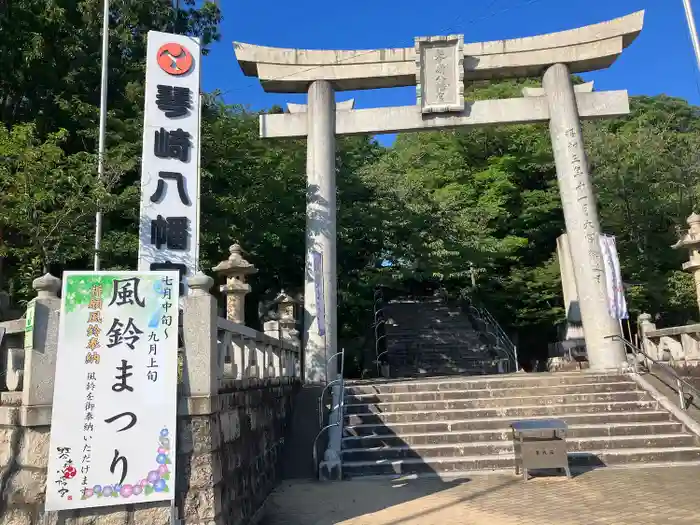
[346,372,634,394]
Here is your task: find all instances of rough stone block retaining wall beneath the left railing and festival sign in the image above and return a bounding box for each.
[0,377,298,525]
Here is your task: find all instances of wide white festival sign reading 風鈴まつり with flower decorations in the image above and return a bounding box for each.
[46,271,179,511]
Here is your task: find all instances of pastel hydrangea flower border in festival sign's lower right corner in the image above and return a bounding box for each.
[82,428,172,499]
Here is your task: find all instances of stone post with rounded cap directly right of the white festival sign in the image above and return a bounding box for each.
[182,272,223,397]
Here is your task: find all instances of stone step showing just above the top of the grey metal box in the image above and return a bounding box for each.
[344,410,671,436]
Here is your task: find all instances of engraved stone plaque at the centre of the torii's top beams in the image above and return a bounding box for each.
[416,35,464,113]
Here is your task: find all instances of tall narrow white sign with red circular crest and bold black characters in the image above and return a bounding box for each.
[138,31,201,295]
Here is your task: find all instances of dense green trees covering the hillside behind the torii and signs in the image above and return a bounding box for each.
[0,0,700,368]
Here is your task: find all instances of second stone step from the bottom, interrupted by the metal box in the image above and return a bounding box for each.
[342,434,700,461]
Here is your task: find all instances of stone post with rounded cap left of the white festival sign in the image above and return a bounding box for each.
[22,273,61,416]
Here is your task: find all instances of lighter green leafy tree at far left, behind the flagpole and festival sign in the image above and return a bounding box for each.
[0,124,114,292]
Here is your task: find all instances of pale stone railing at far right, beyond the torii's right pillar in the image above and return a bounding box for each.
[637,314,700,369]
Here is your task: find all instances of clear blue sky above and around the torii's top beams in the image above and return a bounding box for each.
[202,0,700,143]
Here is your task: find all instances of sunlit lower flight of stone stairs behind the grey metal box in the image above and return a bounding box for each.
[342,372,700,477]
